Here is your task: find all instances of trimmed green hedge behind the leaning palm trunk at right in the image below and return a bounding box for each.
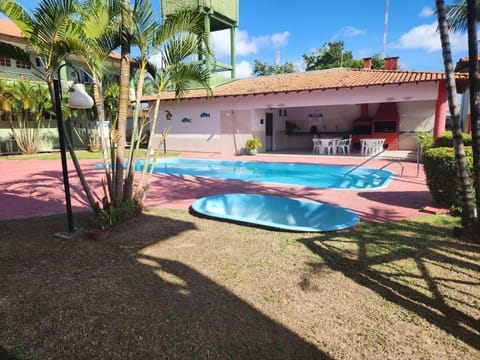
[423,147,473,212]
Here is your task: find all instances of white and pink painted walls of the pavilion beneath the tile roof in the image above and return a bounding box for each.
[152,82,438,153]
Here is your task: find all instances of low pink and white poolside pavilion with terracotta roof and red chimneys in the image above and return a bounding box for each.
[144,57,468,154]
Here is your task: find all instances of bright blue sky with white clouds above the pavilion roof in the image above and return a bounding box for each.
[6,0,468,77]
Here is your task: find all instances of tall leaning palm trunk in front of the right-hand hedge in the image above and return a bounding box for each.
[435,0,475,227]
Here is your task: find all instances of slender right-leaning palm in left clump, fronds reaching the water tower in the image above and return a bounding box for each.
[123,0,209,207]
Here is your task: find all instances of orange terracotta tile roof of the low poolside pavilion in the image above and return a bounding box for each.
[143,69,468,101]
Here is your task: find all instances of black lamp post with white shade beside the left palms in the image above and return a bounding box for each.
[53,63,93,239]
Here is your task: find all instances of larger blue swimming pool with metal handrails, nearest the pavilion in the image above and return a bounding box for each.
[132,158,395,190]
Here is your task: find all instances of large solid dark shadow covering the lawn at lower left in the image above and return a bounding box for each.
[0,214,329,359]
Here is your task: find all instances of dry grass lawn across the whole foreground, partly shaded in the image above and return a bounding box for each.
[0,209,480,359]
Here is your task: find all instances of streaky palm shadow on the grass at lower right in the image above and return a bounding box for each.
[299,221,480,349]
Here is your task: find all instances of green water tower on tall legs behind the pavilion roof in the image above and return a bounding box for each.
[160,0,238,79]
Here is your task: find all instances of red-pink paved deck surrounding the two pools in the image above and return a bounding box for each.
[0,153,442,222]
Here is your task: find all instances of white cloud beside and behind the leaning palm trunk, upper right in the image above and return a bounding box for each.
[393,22,468,52]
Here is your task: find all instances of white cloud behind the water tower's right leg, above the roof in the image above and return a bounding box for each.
[212,29,290,58]
